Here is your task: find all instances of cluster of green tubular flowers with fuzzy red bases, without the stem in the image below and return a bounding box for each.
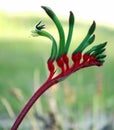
[34,6,107,80]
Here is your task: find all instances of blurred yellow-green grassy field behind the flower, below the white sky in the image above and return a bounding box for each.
[0,10,114,130]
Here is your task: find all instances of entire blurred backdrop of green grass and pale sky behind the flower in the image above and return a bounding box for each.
[0,0,114,130]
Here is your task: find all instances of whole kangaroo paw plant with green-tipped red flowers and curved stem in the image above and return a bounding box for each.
[11,6,107,130]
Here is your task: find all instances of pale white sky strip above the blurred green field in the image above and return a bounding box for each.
[0,0,114,26]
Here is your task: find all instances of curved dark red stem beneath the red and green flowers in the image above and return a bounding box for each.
[10,57,102,130]
